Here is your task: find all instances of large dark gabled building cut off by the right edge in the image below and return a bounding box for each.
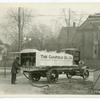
[77,14,100,59]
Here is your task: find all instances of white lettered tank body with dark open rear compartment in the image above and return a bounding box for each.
[21,49,73,69]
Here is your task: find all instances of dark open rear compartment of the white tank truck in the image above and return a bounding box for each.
[21,53,36,66]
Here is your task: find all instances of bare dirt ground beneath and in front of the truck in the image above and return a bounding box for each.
[0,70,93,95]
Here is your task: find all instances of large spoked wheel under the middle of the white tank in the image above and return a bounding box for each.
[47,70,59,83]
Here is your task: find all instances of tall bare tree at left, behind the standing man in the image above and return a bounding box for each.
[1,8,32,50]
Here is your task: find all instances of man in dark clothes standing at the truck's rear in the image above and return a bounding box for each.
[11,57,20,84]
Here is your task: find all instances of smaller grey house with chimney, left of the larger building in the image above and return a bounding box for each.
[58,22,77,49]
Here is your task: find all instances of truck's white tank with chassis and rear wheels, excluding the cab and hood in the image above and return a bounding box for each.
[20,49,89,83]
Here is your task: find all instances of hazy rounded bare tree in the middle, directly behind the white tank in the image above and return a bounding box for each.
[26,24,52,50]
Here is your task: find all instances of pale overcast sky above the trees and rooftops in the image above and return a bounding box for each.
[0,4,100,43]
